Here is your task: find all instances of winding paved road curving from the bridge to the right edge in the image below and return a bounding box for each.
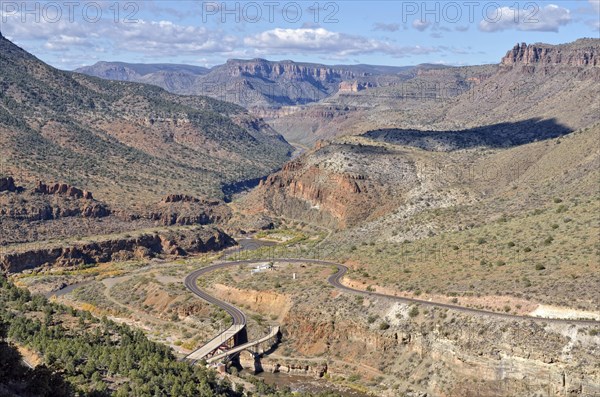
[185,258,600,360]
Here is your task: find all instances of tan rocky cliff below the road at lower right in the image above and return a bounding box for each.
[283,295,600,397]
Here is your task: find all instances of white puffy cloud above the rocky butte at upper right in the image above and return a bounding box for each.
[479,4,572,32]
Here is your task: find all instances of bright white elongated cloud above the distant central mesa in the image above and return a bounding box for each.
[244,28,439,57]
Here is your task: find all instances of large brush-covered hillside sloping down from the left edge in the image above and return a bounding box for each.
[0,36,292,206]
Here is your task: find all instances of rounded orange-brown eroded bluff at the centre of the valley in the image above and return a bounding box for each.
[247,143,416,229]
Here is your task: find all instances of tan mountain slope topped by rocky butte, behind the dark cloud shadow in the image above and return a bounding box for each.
[264,38,600,146]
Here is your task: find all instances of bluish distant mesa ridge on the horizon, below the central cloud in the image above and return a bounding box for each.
[76,58,414,108]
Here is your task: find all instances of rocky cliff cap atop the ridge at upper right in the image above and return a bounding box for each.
[502,39,600,67]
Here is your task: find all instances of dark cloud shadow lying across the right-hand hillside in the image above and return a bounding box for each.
[363,119,573,151]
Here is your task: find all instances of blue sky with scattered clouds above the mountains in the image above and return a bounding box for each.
[0,0,600,70]
